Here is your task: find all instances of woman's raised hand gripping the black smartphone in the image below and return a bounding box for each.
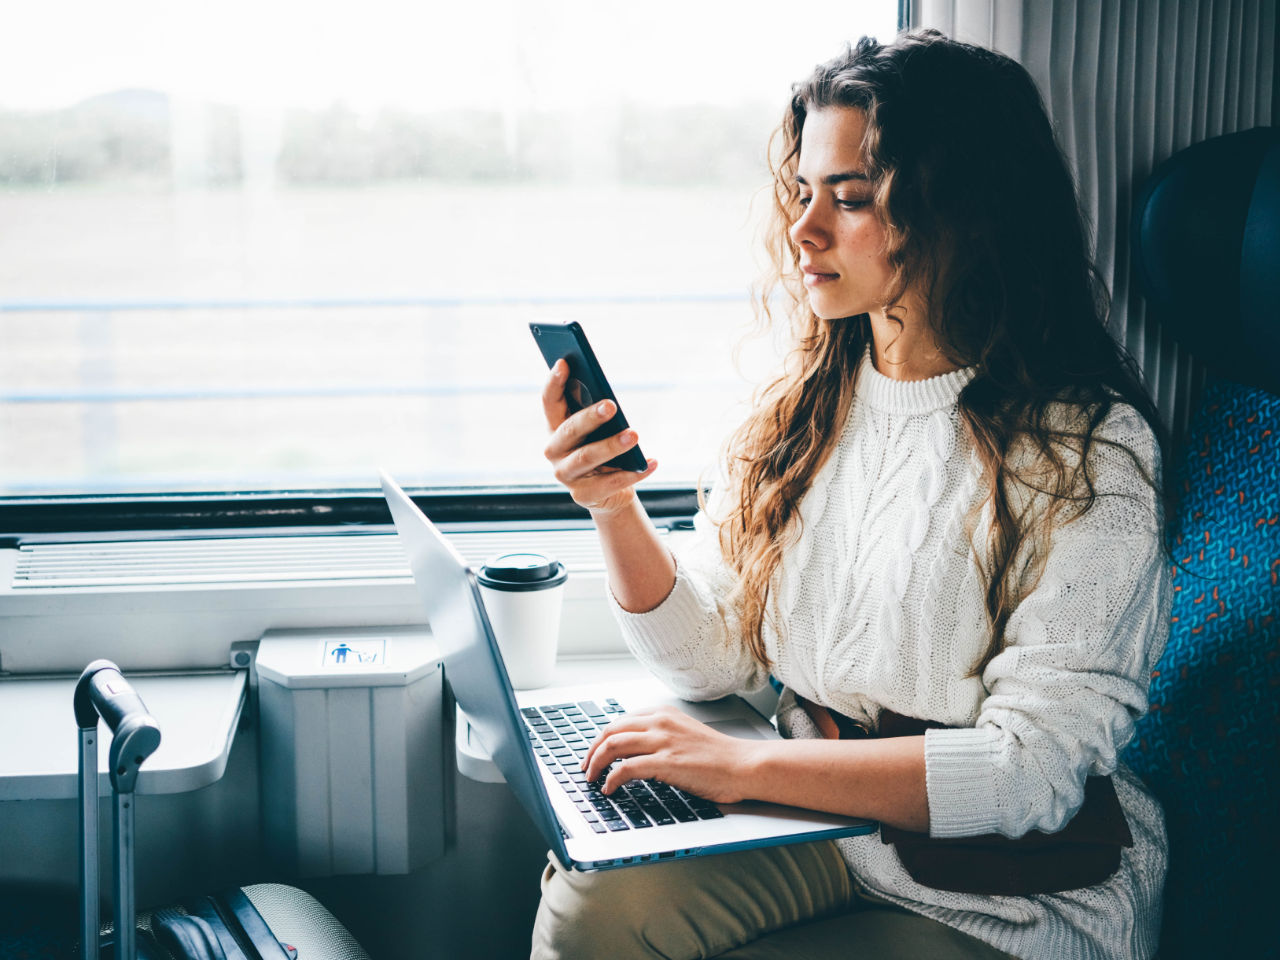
[543,360,658,516]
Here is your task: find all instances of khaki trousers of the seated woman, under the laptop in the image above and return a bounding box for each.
[531,842,1009,960]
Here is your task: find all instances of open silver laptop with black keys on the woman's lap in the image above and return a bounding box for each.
[381,474,877,870]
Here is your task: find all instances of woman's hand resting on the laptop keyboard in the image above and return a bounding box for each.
[582,707,759,804]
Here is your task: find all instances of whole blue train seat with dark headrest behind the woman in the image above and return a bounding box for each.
[1125,127,1280,960]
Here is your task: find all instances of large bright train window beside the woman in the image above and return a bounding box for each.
[0,0,899,499]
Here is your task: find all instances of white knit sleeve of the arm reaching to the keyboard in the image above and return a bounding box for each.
[924,406,1171,837]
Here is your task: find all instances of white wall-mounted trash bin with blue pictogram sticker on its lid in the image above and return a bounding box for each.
[257,627,448,877]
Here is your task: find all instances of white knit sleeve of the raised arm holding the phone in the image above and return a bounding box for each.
[609,488,768,700]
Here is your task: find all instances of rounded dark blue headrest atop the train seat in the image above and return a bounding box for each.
[1133,127,1280,393]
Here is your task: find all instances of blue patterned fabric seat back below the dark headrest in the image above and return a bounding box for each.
[1125,379,1280,957]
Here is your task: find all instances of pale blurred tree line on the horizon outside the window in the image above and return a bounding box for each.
[0,90,778,189]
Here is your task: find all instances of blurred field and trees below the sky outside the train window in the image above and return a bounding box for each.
[0,90,774,495]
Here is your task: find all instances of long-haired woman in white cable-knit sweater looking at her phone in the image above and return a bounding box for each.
[534,32,1169,957]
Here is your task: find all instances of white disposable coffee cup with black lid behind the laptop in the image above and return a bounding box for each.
[476,553,568,690]
